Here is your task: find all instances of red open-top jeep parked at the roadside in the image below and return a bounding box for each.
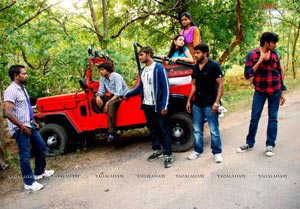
[35,43,194,154]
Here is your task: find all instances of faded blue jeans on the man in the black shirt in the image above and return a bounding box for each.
[192,105,222,154]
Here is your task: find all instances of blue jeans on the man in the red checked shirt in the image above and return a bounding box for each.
[246,90,281,147]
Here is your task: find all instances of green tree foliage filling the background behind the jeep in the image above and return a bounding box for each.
[0,0,300,97]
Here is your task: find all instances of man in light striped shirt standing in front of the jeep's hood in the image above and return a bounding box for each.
[4,65,54,191]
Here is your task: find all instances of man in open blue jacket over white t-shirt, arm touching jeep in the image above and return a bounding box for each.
[125,46,173,168]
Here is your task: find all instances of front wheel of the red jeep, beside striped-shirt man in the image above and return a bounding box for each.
[40,124,68,155]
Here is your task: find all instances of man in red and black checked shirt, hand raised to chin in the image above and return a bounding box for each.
[237,32,286,157]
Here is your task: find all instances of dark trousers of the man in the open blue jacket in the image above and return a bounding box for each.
[143,105,172,155]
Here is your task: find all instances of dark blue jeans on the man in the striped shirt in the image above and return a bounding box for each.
[13,124,46,185]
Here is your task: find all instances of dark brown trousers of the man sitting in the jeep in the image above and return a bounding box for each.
[100,96,122,134]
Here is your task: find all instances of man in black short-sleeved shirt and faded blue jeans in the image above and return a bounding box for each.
[186,43,224,163]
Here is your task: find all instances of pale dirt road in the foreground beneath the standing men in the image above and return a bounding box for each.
[0,91,300,209]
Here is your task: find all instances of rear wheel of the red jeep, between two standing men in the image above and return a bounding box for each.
[169,112,194,152]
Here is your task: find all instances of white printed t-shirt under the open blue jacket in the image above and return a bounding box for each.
[141,62,156,105]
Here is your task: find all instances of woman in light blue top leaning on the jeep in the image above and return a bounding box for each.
[161,35,194,64]
